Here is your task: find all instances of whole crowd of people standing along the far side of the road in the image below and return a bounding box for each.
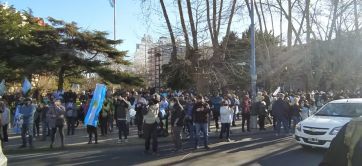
[0,89,361,154]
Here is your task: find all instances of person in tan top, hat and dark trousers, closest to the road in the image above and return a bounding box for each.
[143,93,161,154]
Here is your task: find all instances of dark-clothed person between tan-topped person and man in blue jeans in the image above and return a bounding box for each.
[170,98,185,152]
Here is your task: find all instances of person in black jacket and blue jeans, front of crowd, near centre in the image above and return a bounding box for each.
[193,95,209,150]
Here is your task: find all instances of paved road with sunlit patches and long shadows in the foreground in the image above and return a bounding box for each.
[8,132,325,166]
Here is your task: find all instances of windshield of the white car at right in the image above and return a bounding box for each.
[315,103,362,117]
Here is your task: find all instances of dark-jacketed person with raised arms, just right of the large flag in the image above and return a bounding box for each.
[114,93,131,143]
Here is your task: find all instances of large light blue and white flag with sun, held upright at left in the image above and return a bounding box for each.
[84,84,107,127]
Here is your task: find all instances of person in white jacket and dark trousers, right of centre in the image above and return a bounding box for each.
[219,101,234,142]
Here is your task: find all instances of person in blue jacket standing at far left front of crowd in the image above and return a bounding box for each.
[19,98,36,148]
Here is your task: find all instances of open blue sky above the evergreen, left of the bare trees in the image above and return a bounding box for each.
[4,0,146,59]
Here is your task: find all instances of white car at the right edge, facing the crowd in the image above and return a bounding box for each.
[294,98,362,148]
